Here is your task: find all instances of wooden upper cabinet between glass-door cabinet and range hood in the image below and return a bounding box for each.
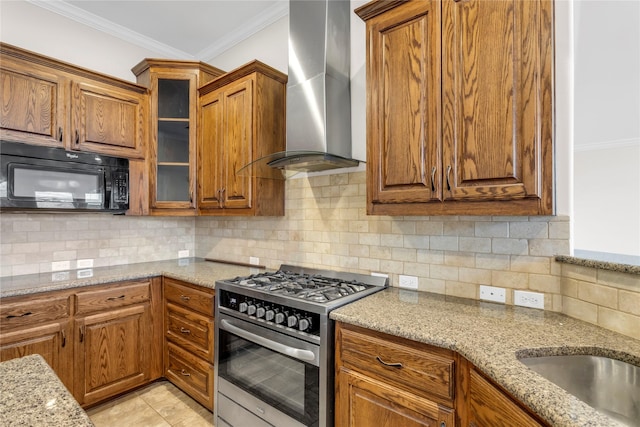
[197,61,287,216]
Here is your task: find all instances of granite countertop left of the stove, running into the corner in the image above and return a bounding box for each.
[0,258,264,298]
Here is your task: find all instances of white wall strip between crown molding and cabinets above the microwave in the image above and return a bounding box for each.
[0,0,164,82]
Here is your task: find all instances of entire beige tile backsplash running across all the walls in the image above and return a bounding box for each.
[0,172,640,339]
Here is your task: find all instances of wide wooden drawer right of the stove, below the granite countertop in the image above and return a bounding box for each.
[338,329,455,401]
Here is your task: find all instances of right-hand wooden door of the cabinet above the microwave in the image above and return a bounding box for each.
[71,82,147,158]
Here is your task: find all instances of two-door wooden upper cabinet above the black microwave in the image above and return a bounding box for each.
[0,43,149,159]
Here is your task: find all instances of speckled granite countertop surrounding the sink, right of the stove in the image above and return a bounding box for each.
[330,288,640,427]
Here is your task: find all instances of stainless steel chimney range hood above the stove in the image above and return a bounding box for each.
[238,0,360,179]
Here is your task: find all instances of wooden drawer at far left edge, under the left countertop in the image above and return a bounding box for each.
[0,295,70,331]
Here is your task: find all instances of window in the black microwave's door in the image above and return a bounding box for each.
[12,165,103,205]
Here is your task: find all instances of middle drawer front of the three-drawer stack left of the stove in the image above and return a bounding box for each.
[166,303,214,363]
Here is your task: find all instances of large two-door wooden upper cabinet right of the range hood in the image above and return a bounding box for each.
[356,0,553,215]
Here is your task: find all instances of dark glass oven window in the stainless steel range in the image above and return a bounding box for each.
[218,330,320,426]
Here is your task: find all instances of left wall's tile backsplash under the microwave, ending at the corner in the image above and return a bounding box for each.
[0,212,195,276]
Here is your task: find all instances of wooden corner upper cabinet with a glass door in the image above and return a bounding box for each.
[132,59,224,215]
